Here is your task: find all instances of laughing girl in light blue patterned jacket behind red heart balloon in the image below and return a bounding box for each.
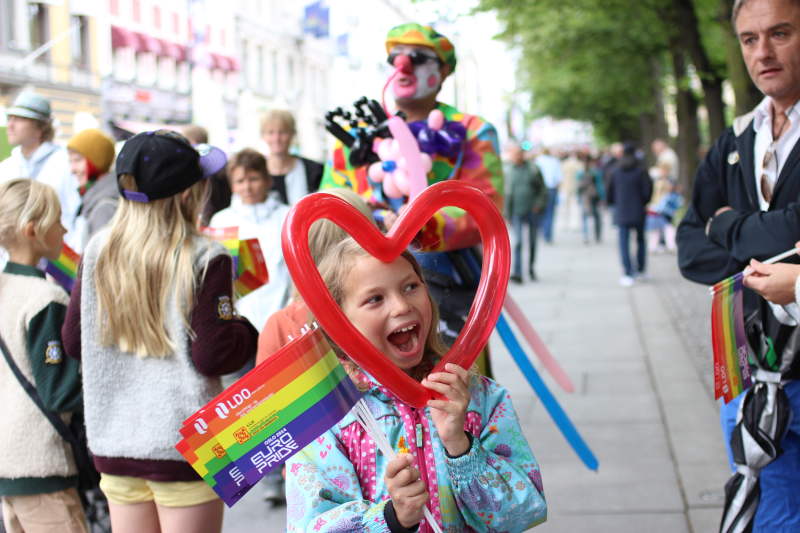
[286,238,546,532]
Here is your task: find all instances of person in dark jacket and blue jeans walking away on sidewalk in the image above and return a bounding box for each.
[608,140,653,287]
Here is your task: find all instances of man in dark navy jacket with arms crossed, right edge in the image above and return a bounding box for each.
[678,0,800,532]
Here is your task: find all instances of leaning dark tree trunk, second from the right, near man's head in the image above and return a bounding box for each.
[673,0,726,143]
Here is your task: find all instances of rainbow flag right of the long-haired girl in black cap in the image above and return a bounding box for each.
[200,226,269,298]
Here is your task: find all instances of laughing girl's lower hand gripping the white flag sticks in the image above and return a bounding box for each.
[383,453,428,529]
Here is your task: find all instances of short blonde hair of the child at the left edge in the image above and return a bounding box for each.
[0,179,61,246]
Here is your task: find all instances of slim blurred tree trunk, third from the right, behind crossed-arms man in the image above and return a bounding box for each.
[670,48,700,196]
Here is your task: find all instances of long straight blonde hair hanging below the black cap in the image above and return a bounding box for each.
[94,174,206,357]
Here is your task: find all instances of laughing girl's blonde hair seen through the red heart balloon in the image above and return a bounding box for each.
[319,237,447,383]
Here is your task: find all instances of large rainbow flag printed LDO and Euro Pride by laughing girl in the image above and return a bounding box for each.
[175,328,361,506]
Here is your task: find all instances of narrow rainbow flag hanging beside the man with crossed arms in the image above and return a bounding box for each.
[711,272,752,403]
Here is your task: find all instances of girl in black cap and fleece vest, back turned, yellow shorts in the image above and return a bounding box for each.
[62,131,257,533]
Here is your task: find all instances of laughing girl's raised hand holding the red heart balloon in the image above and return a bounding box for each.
[422,363,469,457]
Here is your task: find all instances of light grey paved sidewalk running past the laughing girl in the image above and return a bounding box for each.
[224,217,729,533]
